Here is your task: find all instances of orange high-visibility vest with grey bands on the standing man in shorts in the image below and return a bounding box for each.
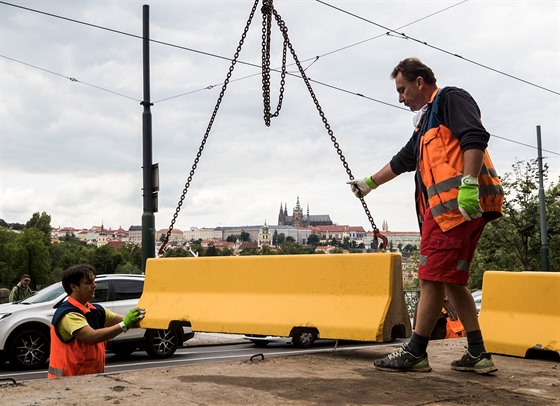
[417,89,504,231]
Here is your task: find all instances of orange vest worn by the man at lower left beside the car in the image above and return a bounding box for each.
[48,297,105,378]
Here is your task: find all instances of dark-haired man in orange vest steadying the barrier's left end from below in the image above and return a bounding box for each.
[48,265,145,378]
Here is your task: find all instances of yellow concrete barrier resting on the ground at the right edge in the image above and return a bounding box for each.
[479,271,560,357]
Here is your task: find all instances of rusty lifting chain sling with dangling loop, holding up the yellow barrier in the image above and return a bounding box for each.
[158,0,387,255]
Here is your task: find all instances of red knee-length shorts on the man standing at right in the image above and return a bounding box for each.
[418,208,487,285]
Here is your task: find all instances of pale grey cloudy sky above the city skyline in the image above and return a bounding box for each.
[0,0,560,235]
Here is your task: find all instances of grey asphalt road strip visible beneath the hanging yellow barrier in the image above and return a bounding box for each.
[0,334,402,382]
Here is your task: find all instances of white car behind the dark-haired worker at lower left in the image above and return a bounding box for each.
[0,274,194,369]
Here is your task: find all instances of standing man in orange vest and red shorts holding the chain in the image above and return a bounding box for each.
[348,58,504,374]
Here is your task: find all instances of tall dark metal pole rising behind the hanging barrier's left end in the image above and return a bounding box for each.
[140,4,159,273]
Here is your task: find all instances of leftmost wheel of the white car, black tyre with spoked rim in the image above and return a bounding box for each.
[8,330,50,369]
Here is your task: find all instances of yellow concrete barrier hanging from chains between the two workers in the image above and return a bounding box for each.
[139,253,411,342]
